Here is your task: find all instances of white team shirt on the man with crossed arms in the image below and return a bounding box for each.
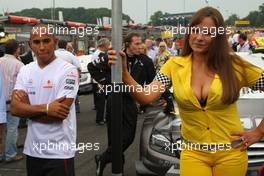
[15,58,79,159]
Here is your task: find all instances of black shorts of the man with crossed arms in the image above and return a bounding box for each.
[27,156,75,176]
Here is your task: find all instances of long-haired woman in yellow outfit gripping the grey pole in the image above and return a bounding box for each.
[109,7,264,176]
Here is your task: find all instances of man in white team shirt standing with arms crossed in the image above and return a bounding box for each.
[11,25,78,176]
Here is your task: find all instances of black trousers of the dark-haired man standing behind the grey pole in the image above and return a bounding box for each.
[102,95,137,163]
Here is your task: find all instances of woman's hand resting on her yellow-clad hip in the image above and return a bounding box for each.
[231,127,264,151]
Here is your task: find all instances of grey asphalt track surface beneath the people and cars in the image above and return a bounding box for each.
[0,94,143,176]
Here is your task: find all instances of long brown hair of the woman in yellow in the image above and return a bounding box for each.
[182,7,248,104]
